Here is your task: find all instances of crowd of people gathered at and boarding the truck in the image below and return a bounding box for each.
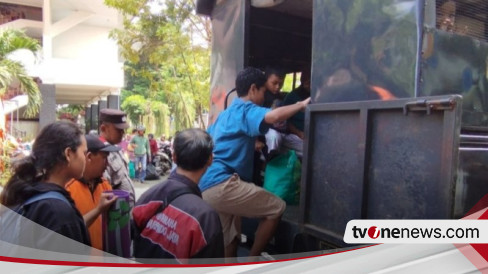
[0,68,310,263]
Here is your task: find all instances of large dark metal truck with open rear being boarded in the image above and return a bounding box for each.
[197,0,488,254]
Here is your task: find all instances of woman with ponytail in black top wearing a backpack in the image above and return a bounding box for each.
[0,121,90,252]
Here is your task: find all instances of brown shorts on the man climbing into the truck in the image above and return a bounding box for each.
[202,174,286,246]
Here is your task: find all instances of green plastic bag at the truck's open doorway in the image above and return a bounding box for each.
[263,150,302,205]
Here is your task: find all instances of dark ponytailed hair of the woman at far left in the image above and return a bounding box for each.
[0,121,83,207]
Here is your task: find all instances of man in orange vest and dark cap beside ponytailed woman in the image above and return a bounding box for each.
[66,134,120,250]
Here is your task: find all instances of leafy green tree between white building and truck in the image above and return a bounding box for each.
[105,0,211,134]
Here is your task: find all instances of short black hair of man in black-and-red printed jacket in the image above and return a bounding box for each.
[173,128,213,171]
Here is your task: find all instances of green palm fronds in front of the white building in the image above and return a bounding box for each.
[0,29,42,131]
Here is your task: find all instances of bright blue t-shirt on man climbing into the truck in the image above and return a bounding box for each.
[199,98,270,191]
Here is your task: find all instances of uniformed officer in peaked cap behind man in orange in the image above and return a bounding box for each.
[100,109,135,208]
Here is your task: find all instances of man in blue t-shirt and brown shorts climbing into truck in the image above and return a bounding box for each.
[199,68,310,257]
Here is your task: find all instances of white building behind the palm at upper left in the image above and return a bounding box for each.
[0,0,124,135]
